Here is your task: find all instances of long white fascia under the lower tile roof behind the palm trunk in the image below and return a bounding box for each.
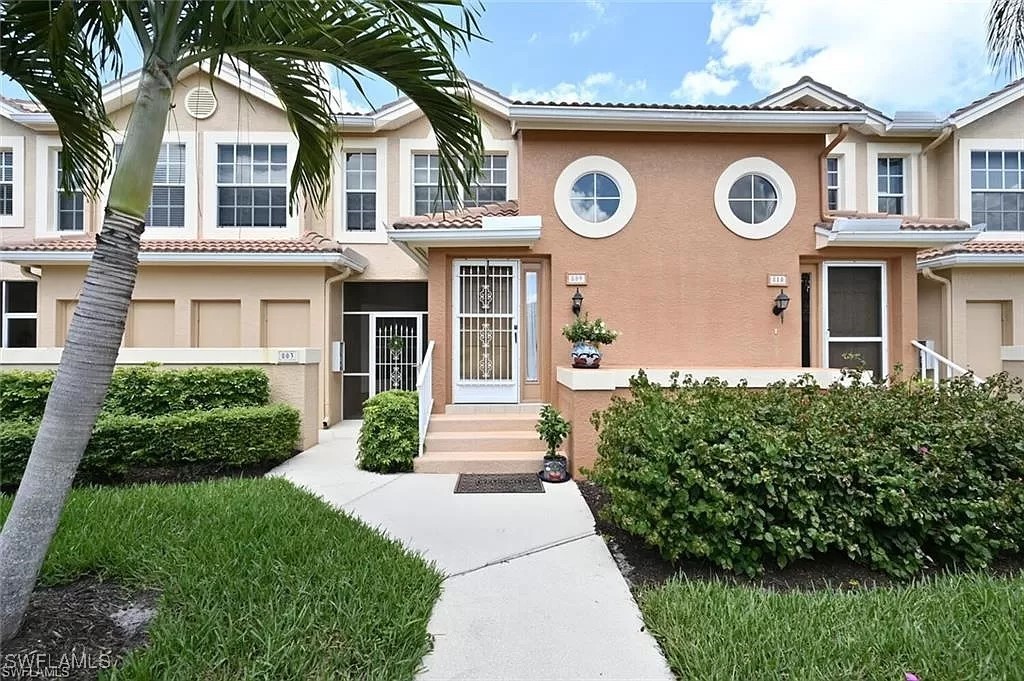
[0,249,367,272]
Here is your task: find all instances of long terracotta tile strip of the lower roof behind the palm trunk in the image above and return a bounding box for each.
[0,231,345,253]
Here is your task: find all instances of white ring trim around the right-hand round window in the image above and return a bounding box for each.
[715,156,797,239]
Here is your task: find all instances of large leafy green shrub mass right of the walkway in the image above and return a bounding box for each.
[591,374,1024,577]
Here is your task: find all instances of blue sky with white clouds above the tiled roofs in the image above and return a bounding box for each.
[2,0,1008,114]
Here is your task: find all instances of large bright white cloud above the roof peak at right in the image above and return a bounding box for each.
[688,0,998,111]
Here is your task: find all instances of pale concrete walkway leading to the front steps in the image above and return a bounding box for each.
[270,424,673,681]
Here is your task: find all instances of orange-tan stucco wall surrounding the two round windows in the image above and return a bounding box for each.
[429,131,918,411]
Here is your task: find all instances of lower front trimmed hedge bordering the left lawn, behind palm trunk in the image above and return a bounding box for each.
[0,405,299,487]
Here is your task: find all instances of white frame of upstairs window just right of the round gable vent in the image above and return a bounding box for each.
[200,132,302,241]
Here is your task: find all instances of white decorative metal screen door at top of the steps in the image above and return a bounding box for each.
[452,260,519,403]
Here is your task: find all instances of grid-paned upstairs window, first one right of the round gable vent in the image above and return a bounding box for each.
[217,144,288,227]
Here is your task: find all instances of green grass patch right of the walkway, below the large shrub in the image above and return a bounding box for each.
[639,574,1024,681]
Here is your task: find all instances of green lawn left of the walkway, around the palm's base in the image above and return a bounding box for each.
[0,479,440,681]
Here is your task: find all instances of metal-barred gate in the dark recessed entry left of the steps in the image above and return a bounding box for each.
[370,314,423,395]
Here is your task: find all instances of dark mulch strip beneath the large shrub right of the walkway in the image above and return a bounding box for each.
[578,480,1024,591]
